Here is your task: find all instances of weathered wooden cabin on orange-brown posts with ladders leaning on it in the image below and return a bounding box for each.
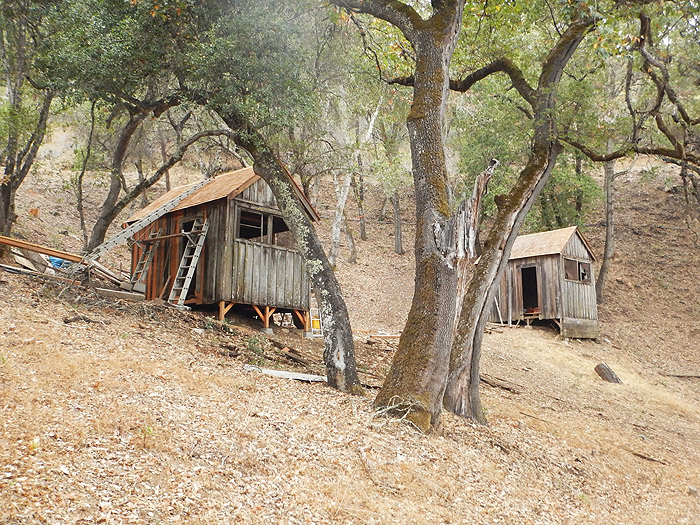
[127,168,318,332]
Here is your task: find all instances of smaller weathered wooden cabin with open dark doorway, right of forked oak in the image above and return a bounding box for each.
[490,226,598,338]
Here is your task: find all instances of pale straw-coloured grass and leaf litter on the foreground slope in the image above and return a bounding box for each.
[0,276,700,523]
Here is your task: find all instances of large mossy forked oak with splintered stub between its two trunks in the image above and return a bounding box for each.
[332,0,592,431]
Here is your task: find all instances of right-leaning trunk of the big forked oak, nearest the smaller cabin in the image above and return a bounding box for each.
[444,18,593,422]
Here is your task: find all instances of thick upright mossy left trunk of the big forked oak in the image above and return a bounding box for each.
[375,19,463,431]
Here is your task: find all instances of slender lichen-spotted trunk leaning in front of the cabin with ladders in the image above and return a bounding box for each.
[216,108,362,394]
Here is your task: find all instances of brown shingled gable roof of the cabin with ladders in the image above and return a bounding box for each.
[126,168,319,223]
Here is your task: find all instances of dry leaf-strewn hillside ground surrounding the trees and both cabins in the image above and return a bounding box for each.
[0,162,700,523]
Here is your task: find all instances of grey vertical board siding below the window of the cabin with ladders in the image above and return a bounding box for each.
[226,240,309,310]
